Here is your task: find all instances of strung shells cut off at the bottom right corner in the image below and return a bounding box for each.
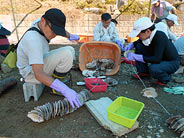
[166,115,184,138]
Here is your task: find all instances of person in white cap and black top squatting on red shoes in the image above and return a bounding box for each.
[124,17,180,85]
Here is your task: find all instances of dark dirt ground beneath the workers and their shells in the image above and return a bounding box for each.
[0,45,184,138]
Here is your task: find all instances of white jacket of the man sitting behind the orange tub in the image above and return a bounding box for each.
[93,22,125,44]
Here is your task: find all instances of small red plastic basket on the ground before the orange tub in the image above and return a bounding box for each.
[84,78,108,92]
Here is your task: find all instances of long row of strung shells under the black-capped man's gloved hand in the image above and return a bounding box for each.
[27,89,91,123]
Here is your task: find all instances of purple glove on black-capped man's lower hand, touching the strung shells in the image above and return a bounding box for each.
[50,79,81,108]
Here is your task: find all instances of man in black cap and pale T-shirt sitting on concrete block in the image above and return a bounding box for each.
[17,8,81,108]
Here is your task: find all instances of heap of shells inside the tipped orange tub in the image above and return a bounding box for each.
[86,59,115,72]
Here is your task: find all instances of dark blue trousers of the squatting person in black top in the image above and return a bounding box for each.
[135,43,180,82]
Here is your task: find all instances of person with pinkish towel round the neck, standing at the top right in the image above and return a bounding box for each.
[151,0,175,23]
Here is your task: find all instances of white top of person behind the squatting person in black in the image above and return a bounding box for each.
[155,19,178,41]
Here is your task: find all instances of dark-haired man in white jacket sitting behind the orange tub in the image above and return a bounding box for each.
[93,13,125,51]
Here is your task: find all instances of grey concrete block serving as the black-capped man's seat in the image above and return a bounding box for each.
[23,82,45,102]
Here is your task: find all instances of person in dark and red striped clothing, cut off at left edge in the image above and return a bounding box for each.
[0,23,11,57]
